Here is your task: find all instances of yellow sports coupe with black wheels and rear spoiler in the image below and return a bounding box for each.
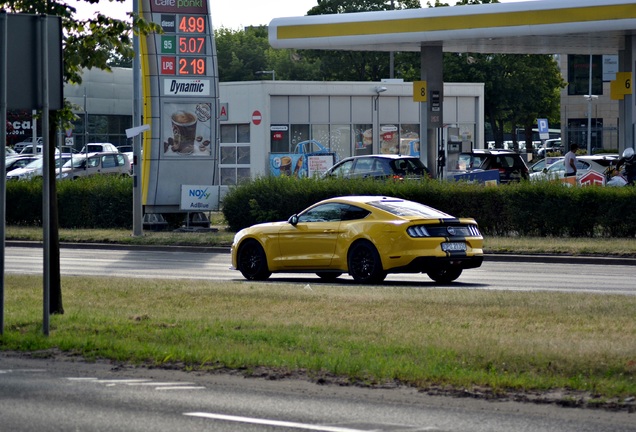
[232,196,484,283]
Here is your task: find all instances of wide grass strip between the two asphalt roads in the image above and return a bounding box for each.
[0,275,636,399]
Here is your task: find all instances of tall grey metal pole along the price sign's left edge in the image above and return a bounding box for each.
[132,0,143,237]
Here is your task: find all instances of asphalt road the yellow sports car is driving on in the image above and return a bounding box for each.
[5,246,636,295]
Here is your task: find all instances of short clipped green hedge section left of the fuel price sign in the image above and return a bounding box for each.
[6,176,132,228]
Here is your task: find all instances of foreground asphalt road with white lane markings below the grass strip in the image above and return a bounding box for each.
[0,352,636,432]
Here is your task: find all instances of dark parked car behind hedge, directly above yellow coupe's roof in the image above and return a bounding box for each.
[323,154,430,180]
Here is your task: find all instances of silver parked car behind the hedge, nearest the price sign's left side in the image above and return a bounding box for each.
[58,153,131,179]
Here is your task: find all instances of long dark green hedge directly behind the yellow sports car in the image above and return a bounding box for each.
[222,177,636,237]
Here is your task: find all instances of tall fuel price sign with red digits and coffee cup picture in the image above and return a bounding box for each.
[140,0,219,213]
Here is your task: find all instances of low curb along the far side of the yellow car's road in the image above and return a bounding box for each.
[5,240,636,266]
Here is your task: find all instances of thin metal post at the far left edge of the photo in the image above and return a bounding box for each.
[0,11,8,336]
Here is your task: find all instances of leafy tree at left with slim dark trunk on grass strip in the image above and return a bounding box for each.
[0,0,161,314]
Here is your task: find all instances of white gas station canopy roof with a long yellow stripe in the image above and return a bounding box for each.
[269,0,636,54]
